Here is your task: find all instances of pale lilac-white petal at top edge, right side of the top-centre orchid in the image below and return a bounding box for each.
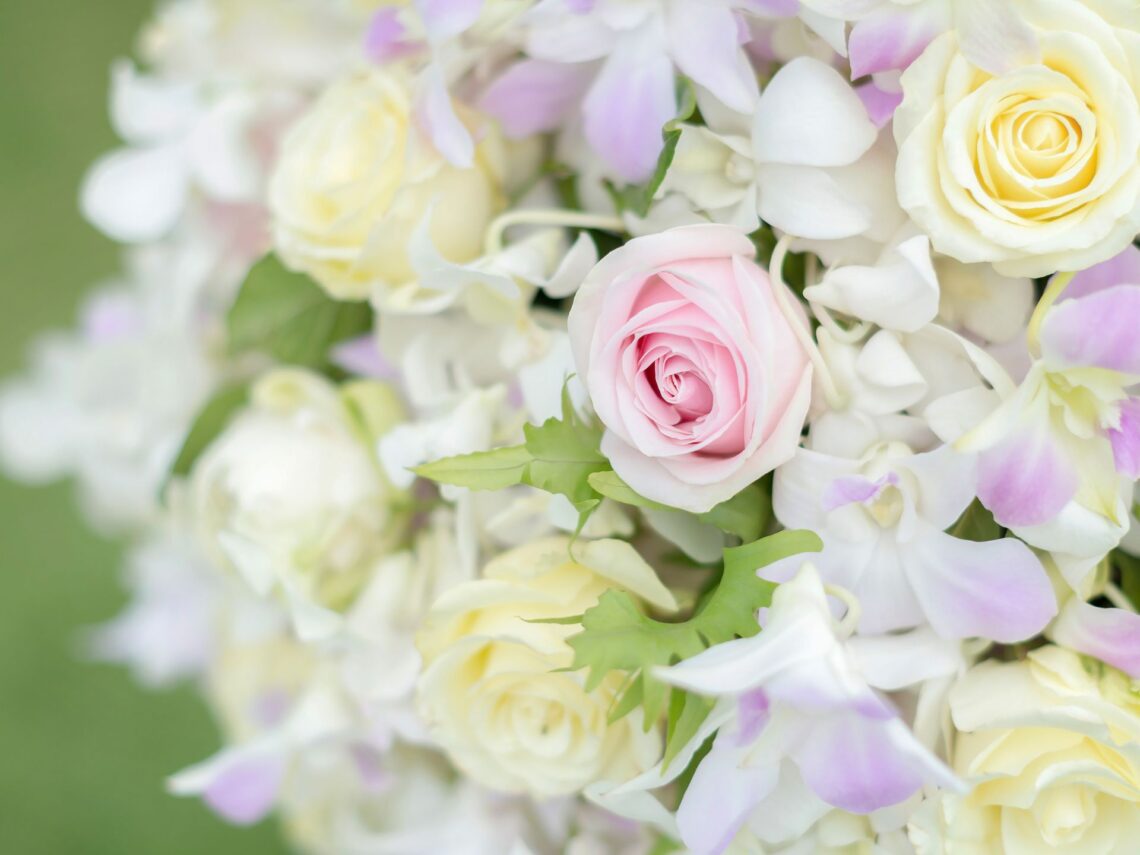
[668,0,759,113]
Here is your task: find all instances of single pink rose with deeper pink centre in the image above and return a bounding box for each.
[570,225,812,513]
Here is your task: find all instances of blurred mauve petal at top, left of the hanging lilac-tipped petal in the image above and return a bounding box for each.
[479,59,593,138]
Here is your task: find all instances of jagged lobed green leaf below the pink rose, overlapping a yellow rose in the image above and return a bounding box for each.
[569,531,823,763]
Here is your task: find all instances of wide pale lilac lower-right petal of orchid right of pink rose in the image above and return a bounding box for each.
[905,529,1057,643]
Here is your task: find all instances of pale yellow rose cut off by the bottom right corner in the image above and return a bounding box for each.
[911,646,1140,855]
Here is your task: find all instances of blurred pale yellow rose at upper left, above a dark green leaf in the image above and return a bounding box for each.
[269,70,504,300]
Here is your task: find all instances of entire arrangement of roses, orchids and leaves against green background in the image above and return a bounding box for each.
[0,0,1140,855]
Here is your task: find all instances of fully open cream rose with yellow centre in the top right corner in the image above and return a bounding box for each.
[895,0,1140,276]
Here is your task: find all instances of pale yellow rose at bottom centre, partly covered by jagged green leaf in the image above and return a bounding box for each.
[417,538,676,797]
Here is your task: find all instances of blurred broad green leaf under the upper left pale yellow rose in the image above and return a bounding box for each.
[226,254,372,369]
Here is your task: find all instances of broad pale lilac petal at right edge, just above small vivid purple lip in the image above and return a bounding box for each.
[1041,284,1140,374]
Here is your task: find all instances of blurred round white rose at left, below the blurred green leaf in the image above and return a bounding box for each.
[189,369,406,637]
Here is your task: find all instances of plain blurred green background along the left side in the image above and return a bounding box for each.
[0,0,284,855]
